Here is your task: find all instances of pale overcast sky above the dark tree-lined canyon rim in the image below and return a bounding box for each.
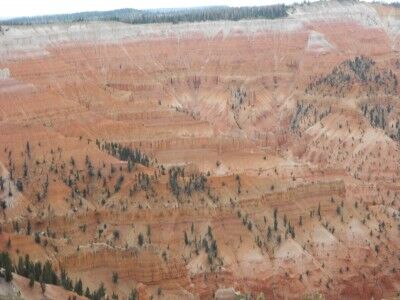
[0,0,394,19]
